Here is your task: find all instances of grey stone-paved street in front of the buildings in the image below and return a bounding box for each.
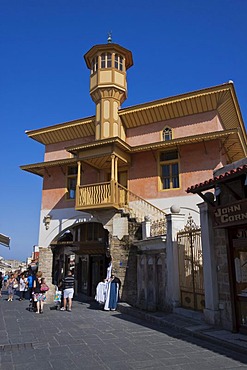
[0,292,247,370]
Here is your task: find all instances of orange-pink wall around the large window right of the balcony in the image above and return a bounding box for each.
[129,140,225,199]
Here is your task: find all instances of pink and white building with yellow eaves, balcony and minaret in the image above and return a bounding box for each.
[21,39,247,328]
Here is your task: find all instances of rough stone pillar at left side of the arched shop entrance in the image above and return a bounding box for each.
[39,247,55,303]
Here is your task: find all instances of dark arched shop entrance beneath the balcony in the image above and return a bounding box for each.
[51,222,109,297]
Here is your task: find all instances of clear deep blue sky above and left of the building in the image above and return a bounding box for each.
[0,0,247,260]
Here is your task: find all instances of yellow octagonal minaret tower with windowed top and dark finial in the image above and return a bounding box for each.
[84,34,133,140]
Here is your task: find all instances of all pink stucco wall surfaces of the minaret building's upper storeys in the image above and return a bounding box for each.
[42,111,226,209]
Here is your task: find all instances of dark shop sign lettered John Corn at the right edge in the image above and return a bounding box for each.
[214,199,247,227]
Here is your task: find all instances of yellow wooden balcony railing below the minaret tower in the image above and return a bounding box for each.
[75,180,128,211]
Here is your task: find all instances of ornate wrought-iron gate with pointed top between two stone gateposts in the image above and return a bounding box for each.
[177,215,205,311]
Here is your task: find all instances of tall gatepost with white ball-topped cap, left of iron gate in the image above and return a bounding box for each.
[166,206,185,308]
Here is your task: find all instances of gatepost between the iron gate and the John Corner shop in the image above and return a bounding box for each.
[198,202,220,325]
